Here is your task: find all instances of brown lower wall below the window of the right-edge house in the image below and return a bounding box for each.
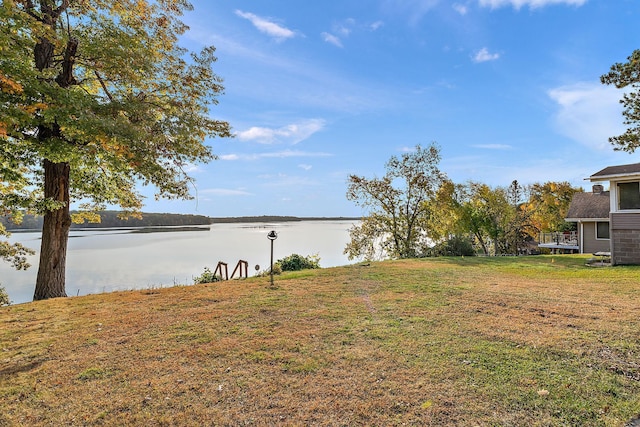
[611,212,640,265]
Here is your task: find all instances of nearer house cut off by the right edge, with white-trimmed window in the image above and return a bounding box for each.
[589,163,640,265]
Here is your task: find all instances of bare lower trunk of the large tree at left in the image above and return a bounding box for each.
[33,160,71,300]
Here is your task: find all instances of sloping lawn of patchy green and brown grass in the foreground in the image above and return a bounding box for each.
[0,256,640,426]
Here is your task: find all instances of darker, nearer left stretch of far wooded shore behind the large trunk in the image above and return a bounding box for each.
[0,211,211,230]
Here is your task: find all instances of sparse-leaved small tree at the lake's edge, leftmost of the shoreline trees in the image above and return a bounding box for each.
[344,144,445,259]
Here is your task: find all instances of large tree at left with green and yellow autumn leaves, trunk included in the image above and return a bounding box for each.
[0,0,230,299]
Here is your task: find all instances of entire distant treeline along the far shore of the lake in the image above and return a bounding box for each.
[0,211,360,230]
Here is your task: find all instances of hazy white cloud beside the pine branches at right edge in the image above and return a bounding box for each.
[548,83,624,150]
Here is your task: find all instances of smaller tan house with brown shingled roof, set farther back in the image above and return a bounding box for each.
[565,185,611,254]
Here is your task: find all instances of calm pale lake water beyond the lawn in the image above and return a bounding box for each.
[0,221,354,304]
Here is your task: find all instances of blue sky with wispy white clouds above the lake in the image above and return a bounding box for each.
[144,0,640,217]
